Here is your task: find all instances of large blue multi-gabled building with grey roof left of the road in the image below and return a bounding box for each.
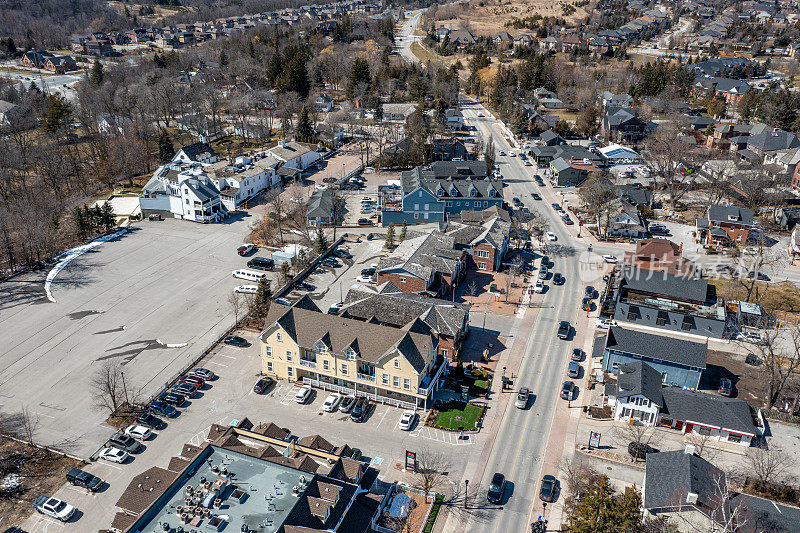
[378,161,503,225]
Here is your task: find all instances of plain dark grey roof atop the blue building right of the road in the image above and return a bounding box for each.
[606,326,708,368]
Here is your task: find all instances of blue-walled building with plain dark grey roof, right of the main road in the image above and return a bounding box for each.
[603,326,708,389]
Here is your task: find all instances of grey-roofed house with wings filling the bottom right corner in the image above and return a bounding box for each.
[642,447,800,533]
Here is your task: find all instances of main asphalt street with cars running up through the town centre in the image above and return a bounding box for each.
[456,104,586,532]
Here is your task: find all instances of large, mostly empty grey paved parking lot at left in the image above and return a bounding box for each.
[0,218,255,457]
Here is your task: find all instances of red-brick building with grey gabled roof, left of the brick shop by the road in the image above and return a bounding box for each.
[377,230,468,297]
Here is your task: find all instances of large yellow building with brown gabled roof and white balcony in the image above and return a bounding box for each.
[260,297,447,409]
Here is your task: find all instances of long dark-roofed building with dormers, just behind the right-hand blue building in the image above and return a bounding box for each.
[613,266,726,339]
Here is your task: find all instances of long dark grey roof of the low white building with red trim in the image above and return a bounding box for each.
[662,387,756,435]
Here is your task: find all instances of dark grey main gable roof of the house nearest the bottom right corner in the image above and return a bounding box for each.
[643,450,727,509]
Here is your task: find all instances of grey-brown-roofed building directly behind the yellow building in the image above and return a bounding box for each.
[339,281,469,361]
